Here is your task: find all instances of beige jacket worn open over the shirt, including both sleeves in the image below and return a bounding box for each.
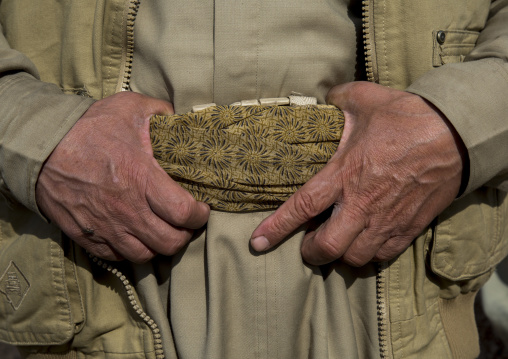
[0,0,508,358]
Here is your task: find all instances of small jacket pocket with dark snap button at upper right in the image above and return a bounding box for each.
[432,30,480,67]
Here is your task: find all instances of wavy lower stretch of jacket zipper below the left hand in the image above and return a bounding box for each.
[88,253,164,359]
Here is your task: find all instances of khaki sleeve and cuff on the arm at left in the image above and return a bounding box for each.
[0,21,93,217]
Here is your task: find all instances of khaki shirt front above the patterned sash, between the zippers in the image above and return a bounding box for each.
[130,0,361,113]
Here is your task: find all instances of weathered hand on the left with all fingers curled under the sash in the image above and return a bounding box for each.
[36,92,209,262]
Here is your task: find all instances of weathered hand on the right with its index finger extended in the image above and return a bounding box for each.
[251,82,466,266]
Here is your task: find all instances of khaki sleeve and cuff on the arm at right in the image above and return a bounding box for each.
[407,0,508,193]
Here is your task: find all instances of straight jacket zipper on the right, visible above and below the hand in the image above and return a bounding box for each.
[362,0,390,359]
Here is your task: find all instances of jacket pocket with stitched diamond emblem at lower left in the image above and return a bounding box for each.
[0,196,75,345]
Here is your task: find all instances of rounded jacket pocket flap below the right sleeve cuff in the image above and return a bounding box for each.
[430,187,508,281]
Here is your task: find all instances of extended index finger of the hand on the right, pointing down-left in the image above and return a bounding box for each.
[250,164,340,252]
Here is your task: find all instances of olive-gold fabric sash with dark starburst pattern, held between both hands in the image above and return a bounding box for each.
[150,105,344,212]
